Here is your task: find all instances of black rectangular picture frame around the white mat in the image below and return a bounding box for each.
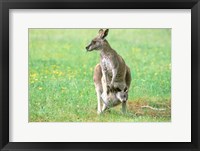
[0,0,200,151]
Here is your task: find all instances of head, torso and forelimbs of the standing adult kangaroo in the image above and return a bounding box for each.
[86,29,131,112]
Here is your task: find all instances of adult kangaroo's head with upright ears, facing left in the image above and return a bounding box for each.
[86,29,109,51]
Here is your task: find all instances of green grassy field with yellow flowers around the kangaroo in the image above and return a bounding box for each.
[29,29,171,122]
